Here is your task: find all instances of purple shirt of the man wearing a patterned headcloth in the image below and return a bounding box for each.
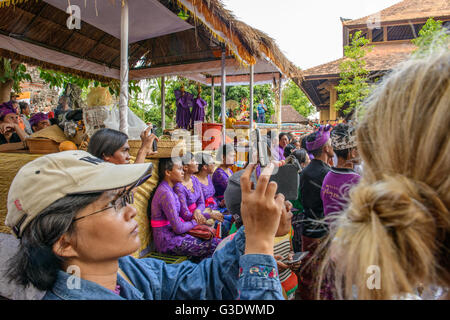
[320,167,361,216]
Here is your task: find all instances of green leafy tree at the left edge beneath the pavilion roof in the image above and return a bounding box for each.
[0,57,31,103]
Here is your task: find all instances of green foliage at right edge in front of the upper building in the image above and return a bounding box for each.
[411,18,450,58]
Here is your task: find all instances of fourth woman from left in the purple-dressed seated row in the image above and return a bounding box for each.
[212,144,236,211]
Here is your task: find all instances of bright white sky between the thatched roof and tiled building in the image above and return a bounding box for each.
[222,0,400,70]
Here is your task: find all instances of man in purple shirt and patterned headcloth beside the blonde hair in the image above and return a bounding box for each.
[320,123,360,216]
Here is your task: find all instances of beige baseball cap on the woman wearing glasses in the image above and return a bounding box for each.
[5,150,152,237]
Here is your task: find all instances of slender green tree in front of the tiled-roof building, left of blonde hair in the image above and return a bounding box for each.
[335,31,372,114]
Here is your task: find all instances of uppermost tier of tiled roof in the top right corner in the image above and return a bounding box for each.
[342,0,450,26]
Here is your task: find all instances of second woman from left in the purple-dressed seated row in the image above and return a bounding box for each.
[173,152,223,224]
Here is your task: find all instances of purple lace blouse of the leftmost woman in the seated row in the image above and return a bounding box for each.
[151,181,197,252]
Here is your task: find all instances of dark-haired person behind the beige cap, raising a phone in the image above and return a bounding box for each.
[87,127,158,164]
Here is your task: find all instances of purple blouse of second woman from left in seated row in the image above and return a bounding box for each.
[173,176,210,219]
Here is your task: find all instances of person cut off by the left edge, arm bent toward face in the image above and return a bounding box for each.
[0,101,28,151]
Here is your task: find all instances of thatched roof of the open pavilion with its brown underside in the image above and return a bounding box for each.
[0,0,302,82]
